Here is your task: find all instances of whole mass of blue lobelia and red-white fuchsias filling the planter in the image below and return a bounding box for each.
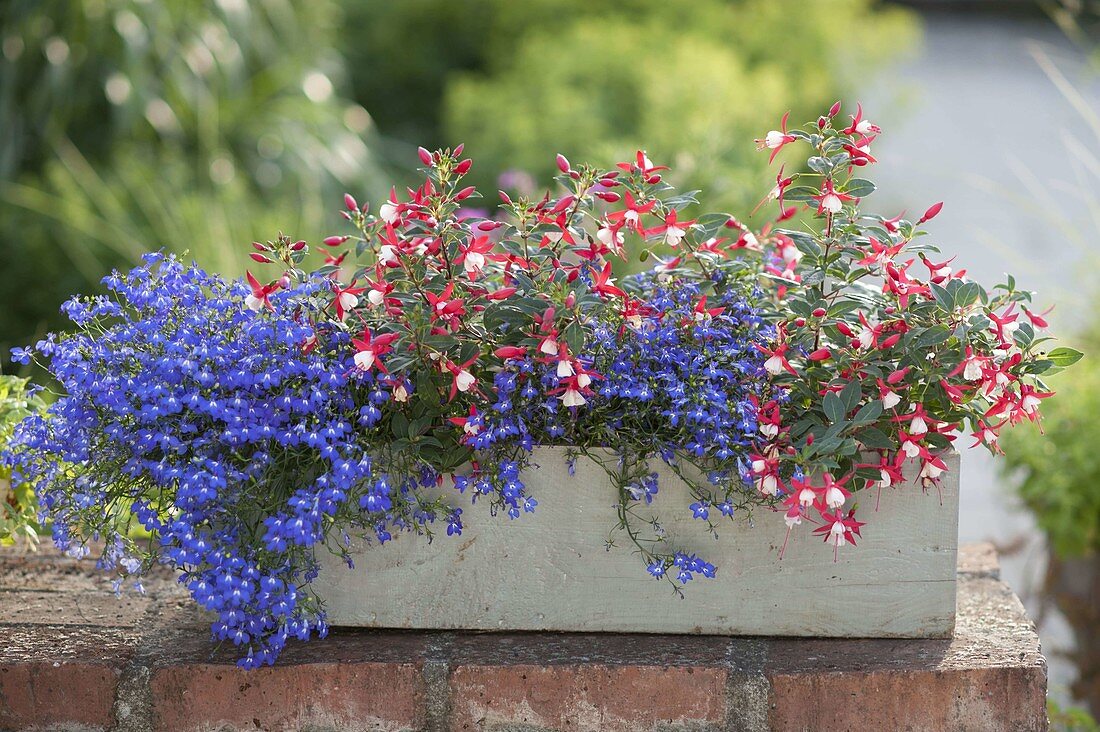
[4,106,1079,667]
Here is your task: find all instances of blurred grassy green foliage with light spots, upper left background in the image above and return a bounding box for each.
[0,0,385,358]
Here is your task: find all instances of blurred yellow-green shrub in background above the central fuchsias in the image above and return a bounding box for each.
[349,0,919,211]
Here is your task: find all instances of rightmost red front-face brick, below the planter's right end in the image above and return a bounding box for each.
[770,667,1047,732]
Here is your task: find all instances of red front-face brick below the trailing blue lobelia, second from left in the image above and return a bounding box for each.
[150,662,425,732]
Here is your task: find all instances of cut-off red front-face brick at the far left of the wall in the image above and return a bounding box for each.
[0,660,121,730]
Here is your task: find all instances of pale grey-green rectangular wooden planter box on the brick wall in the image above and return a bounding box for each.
[314,448,959,637]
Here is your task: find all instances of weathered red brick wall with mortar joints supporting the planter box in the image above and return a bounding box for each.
[0,547,1046,732]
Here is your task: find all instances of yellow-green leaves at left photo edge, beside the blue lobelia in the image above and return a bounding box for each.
[0,375,46,547]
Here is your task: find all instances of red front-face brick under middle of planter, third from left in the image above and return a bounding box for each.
[451,664,726,732]
